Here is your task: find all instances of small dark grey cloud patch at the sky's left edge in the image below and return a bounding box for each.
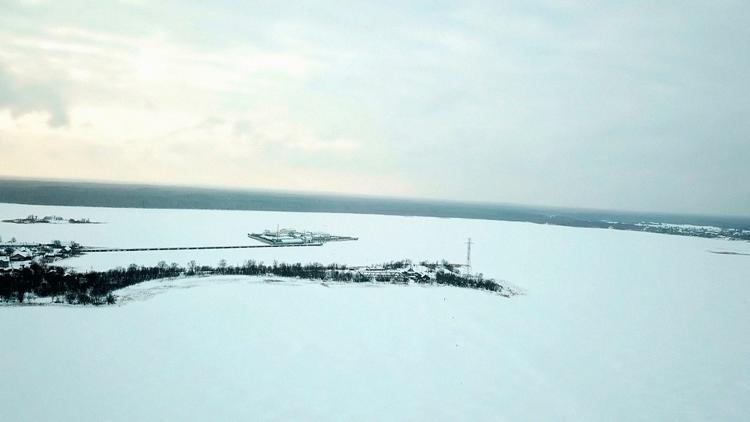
[0,65,69,127]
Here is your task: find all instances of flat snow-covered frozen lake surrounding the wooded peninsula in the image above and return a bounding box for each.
[0,204,750,421]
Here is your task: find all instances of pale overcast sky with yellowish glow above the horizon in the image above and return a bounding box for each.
[0,0,750,215]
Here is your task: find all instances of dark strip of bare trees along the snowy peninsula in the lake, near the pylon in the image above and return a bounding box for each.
[0,260,516,305]
